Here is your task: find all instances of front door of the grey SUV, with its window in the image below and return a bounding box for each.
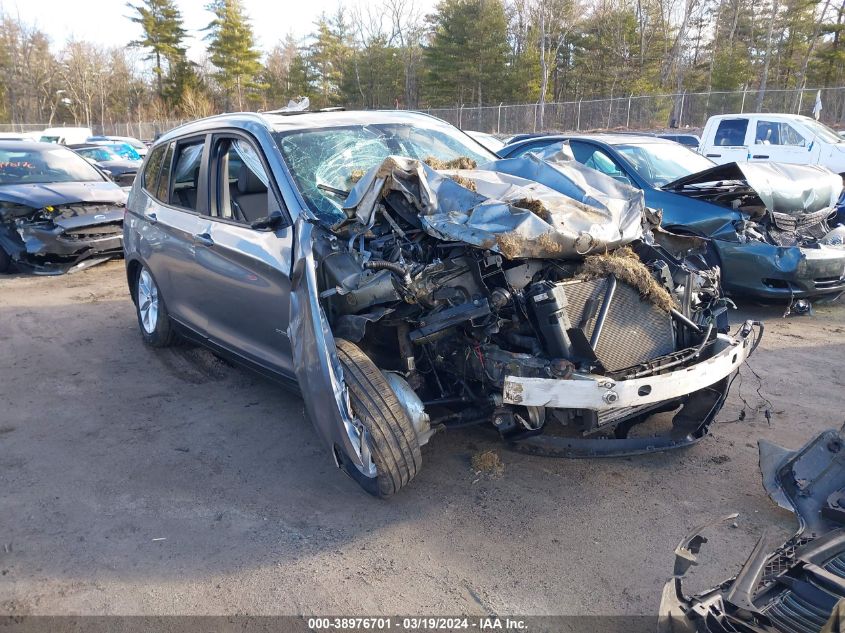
[196,131,294,377]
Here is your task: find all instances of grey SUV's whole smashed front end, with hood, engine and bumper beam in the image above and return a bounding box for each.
[314,155,762,457]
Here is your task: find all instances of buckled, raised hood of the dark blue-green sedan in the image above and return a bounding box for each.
[662,163,842,214]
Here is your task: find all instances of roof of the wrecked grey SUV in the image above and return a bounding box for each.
[156,110,452,145]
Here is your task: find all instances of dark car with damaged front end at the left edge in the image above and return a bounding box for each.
[0,141,126,275]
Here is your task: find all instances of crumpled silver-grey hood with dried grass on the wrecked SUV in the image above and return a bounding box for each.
[343,148,645,259]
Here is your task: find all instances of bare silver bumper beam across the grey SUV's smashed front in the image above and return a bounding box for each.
[502,321,759,411]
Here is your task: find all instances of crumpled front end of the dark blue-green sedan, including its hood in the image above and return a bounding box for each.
[663,158,845,298]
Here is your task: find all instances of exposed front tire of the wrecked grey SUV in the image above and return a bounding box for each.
[335,339,422,498]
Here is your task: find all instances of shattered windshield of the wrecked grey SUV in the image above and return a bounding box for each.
[276,123,496,224]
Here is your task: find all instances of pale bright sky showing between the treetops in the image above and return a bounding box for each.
[0,0,436,60]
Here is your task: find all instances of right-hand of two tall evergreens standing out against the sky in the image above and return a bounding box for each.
[205,0,262,110]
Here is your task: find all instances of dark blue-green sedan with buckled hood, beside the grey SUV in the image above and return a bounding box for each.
[499,134,845,299]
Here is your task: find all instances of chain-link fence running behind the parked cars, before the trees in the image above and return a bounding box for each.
[0,86,845,140]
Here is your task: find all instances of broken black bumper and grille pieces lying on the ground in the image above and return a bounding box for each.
[658,429,845,633]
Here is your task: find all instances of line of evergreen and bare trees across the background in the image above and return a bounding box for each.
[0,0,845,126]
